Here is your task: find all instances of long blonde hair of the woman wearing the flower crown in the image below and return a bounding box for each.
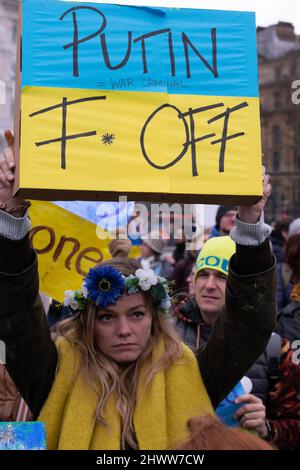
[56,258,183,449]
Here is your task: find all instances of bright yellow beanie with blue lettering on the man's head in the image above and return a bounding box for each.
[195,237,235,279]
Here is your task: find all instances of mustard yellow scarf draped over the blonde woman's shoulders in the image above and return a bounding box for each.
[38,338,214,450]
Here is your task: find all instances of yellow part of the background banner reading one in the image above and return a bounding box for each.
[30,201,140,301]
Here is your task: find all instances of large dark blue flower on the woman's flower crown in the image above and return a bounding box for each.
[84,266,125,308]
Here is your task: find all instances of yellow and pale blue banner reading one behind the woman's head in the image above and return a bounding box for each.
[30,201,141,301]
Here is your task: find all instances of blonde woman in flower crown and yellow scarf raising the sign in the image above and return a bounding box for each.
[0,132,276,450]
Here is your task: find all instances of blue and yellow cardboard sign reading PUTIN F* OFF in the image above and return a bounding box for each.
[15,0,262,203]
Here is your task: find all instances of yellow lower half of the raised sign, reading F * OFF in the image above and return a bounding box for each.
[20,86,262,196]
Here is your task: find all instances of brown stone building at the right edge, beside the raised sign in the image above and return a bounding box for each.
[257,22,300,221]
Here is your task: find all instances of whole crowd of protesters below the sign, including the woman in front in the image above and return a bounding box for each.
[0,127,300,450]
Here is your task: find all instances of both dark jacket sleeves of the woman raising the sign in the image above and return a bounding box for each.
[0,236,276,417]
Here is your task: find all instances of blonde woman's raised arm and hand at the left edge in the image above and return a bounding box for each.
[0,133,58,417]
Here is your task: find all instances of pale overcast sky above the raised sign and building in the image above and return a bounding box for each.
[77,0,300,34]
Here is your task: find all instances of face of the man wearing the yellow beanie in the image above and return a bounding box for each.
[195,269,227,325]
